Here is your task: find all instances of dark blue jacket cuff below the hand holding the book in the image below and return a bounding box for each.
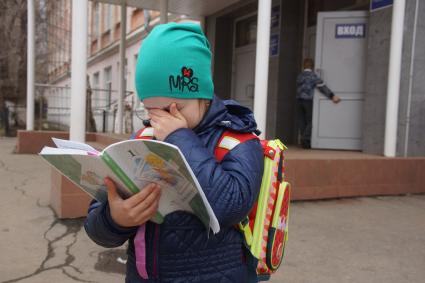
[84,201,137,248]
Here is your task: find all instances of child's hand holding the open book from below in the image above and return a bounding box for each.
[105,178,161,227]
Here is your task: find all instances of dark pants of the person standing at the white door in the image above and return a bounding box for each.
[297,99,313,148]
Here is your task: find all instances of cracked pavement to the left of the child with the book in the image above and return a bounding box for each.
[0,138,125,283]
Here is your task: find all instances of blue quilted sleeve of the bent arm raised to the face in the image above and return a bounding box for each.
[165,129,264,227]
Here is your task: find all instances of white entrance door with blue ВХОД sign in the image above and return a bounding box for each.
[311,11,368,150]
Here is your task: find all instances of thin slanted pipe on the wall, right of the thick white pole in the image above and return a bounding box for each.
[404,0,419,157]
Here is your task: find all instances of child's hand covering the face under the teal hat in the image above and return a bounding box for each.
[149,103,188,141]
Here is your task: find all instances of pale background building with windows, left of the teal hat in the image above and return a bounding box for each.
[45,0,200,133]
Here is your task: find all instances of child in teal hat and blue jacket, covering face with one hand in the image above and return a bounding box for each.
[85,23,263,283]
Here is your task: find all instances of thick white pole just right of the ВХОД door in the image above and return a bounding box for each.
[384,0,406,157]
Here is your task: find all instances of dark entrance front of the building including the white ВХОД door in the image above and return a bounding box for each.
[206,0,425,156]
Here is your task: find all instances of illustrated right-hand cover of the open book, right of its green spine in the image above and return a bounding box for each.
[102,140,220,233]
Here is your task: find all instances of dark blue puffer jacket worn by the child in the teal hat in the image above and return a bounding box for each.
[84,97,263,283]
